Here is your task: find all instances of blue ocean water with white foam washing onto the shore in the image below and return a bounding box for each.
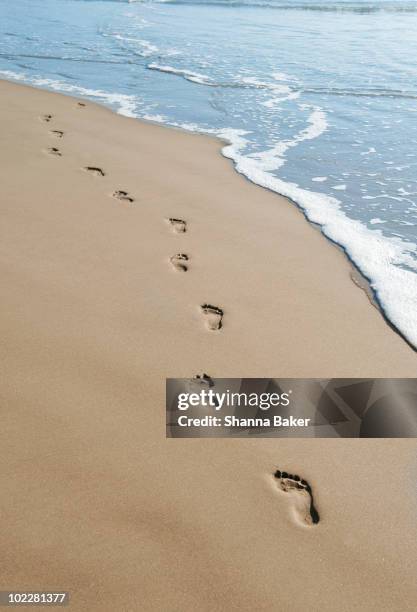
[0,0,417,347]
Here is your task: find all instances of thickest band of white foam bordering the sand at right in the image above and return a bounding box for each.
[218,130,417,348]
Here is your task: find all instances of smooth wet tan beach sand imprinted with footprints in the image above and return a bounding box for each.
[0,82,417,612]
